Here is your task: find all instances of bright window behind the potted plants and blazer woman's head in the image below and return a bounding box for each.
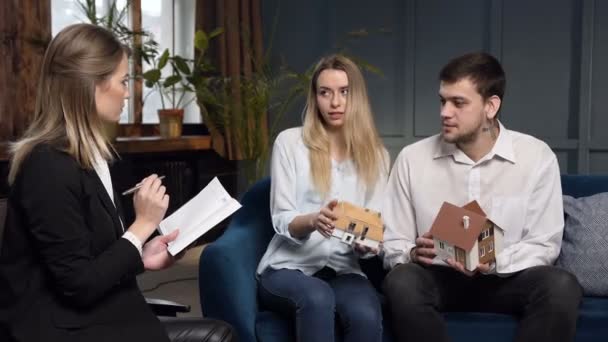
[51,0,201,123]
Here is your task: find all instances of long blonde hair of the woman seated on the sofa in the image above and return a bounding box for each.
[303,55,388,196]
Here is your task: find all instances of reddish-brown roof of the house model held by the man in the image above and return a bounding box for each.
[431,201,490,251]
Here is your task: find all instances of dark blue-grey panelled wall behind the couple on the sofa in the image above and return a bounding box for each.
[262,0,608,173]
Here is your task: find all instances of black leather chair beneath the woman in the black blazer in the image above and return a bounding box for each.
[0,198,238,342]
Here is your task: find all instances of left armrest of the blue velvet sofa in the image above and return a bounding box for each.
[199,178,274,342]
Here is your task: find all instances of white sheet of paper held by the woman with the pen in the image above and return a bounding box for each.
[159,177,241,255]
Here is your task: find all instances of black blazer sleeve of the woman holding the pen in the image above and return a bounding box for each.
[15,148,143,308]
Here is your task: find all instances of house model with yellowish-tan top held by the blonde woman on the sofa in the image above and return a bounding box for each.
[332,202,384,248]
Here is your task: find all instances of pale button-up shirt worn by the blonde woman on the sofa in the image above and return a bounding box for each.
[257,127,388,275]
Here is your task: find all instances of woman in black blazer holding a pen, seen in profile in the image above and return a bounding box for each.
[0,24,232,342]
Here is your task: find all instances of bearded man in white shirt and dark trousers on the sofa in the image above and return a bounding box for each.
[382,53,581,341]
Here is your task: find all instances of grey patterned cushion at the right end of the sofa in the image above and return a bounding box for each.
[556,193,608,296]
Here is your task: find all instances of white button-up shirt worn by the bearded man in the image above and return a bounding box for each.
[382,124,564,273]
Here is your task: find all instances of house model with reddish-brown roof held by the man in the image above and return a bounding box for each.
[431,201,504,271]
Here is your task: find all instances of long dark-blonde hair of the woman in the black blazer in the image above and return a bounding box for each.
[8,24,129,184]
